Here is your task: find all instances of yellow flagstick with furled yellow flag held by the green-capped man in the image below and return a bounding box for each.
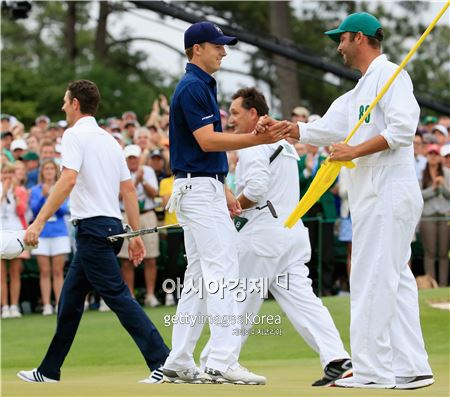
[284,0,450,228]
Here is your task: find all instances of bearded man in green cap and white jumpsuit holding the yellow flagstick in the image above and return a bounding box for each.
[260,13,434,389]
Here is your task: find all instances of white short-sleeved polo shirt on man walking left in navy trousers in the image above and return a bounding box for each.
[61,116,131,219]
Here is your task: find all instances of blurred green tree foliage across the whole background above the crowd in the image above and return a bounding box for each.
[1,1,450,126]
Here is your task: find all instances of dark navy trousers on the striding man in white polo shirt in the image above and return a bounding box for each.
[38,216,169,380]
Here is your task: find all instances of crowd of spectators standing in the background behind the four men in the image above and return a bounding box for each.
[0,95,450,318]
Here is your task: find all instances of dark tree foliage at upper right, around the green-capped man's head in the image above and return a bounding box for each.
[188,1,450,113]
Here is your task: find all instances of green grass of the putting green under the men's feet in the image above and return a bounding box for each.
[1,289,450,397]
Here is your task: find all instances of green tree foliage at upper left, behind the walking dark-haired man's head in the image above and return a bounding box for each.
[1,1,172,126]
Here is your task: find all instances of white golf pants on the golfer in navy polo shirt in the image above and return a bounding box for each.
[164,177,240,371]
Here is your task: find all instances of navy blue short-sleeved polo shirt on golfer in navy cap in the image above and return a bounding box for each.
[169,63,228,174]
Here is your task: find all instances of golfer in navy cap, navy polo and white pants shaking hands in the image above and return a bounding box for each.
[164,22,285,384]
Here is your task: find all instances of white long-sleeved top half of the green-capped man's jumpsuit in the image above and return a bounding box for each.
[299,55,420,166]
